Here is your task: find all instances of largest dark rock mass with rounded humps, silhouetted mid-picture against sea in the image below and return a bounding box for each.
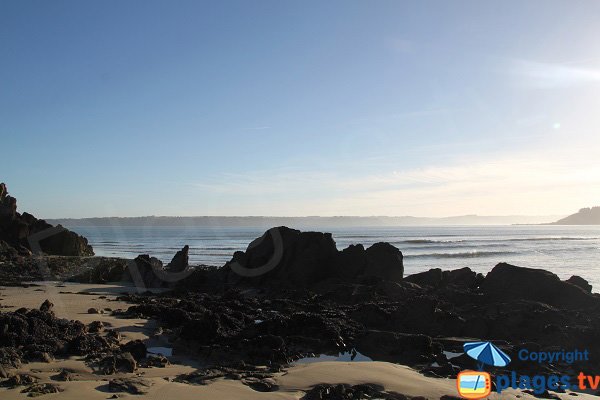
[224,227,404,287]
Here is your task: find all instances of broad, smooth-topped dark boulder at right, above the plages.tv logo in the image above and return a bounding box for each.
[483,263,600,308]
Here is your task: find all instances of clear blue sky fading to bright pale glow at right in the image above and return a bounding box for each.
[0,0,600,218]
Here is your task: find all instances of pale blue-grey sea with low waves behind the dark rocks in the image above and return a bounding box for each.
[68,225,600,291]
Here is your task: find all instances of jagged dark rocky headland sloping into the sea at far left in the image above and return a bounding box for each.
[0,183,94,256]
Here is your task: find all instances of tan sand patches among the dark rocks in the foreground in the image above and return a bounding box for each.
[0,282,596,400]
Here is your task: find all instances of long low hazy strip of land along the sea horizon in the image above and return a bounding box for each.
[47,215,560,229]
